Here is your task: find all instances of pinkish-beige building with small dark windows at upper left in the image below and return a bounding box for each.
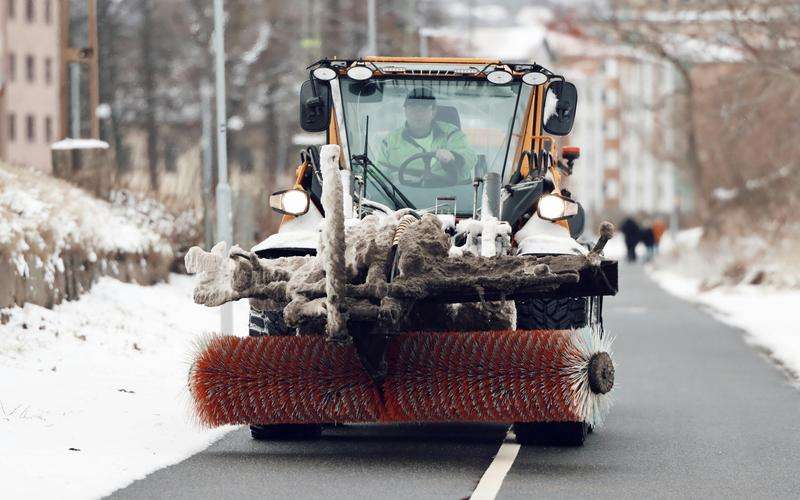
[0,0,60,172]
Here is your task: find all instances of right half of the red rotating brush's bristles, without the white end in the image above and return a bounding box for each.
[381,330,580,422]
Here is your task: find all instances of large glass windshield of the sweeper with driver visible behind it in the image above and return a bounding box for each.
[341,78,530,214]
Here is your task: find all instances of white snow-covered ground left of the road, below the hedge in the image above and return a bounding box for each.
[0,274,248,498]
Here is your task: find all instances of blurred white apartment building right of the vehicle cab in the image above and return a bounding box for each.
[548,32,679,221]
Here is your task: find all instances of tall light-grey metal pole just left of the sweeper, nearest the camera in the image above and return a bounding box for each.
[214,0,233,335]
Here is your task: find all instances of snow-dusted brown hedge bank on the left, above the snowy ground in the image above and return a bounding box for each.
[0,165,175,307]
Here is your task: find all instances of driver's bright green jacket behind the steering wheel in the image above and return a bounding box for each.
[378,121,478,181]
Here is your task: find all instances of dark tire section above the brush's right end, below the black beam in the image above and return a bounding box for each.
[516,297,589,330]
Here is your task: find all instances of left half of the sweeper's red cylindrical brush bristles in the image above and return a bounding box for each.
[189,336,380,426]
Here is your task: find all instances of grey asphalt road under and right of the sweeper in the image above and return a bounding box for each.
[112,267,800,499]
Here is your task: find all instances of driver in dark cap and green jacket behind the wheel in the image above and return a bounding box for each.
[378,87,478,185]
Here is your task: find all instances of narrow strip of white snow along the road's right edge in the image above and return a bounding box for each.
[650,269,800,379]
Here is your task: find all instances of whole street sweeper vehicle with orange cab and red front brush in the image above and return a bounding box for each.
[186,57,617,445]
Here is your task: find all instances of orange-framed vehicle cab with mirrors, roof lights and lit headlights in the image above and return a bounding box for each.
[253,57,586,257]
